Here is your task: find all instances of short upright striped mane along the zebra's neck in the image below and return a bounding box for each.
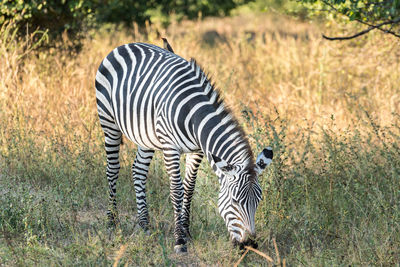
[190,58,254,176]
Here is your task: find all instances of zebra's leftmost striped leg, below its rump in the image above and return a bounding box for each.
[104,131,122,226]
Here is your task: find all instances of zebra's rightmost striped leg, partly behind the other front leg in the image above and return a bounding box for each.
[182,153,203,237]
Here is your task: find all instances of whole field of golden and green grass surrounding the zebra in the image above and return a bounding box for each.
[0,15,400,266]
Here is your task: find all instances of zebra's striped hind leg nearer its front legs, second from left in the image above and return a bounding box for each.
[132,147,154,231]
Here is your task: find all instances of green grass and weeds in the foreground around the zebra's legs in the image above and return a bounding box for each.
[0,109,400,266]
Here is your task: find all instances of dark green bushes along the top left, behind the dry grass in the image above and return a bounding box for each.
[0,0,251,39]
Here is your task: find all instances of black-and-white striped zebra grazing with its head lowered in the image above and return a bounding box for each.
[95,43,272,253]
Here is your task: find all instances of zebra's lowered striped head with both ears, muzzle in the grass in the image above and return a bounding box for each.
[211,147,273,247]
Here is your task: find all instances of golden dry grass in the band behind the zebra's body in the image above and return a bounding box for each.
[0,13,400,143]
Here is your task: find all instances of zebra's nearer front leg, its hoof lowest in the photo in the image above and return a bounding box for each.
[164,150,187,253]
